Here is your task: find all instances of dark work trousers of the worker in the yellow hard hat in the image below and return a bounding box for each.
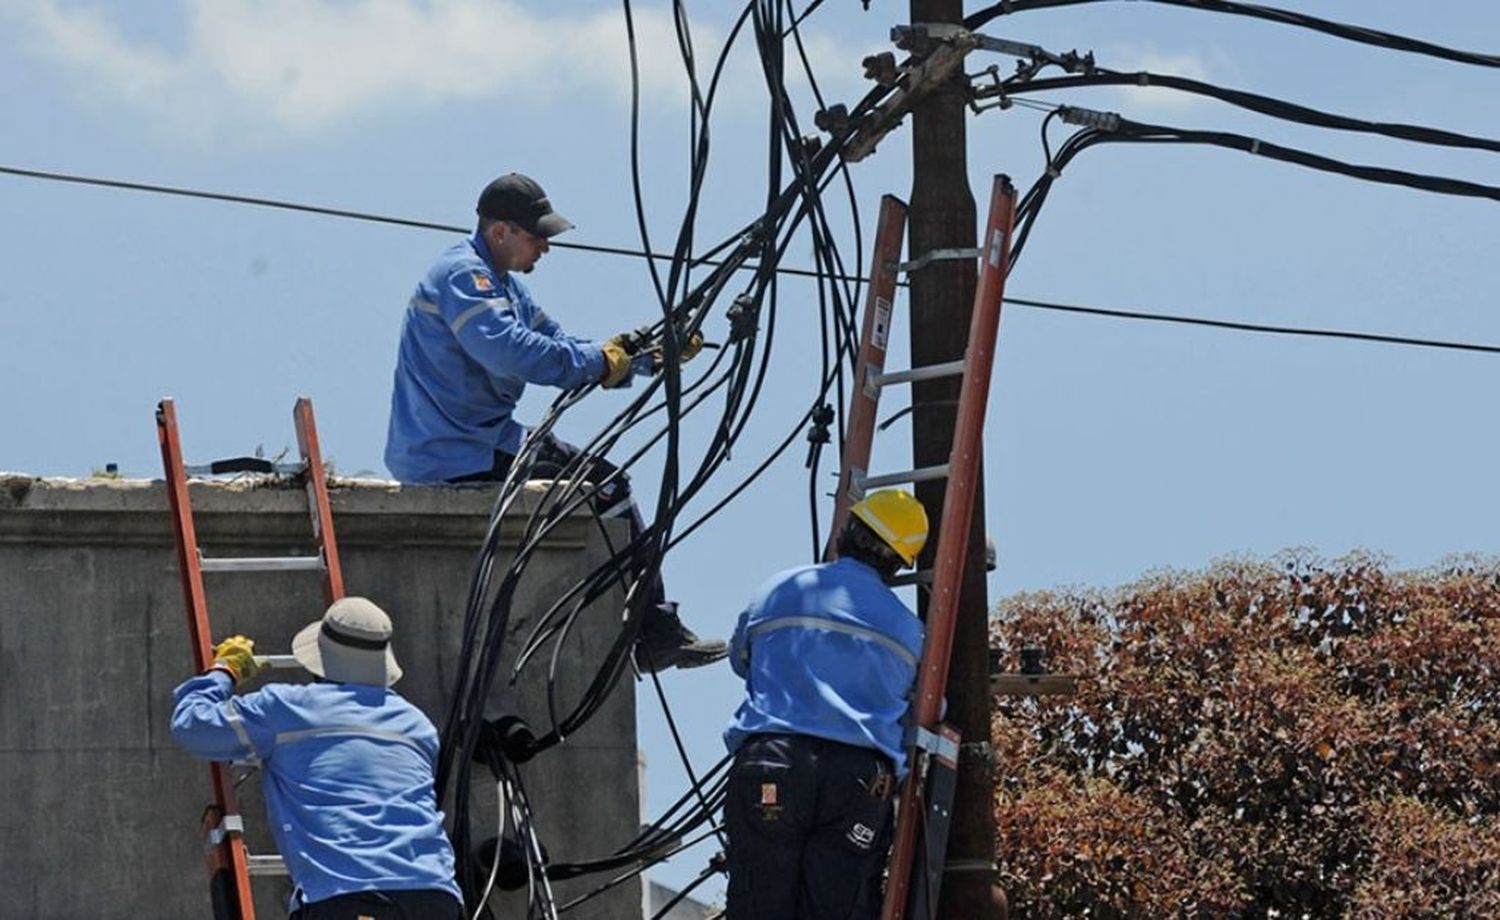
[725,734,896,920]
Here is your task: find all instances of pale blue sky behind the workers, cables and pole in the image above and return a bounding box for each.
[0,0,1500,906]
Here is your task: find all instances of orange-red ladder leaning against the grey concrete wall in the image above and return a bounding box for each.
[156,396,344,920]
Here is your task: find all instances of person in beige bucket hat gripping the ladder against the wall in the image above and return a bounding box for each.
[173,597,464,920]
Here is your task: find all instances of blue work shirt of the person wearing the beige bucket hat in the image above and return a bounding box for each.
[173,671,462,909]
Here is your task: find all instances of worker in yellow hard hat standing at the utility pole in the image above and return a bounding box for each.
[725,489,927,920]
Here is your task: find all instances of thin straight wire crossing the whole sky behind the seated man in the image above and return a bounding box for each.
[11,159,1500,354]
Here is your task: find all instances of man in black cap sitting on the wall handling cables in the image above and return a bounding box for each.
[386,173,726,671]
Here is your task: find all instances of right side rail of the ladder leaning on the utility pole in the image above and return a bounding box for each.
[867,176,1016,920]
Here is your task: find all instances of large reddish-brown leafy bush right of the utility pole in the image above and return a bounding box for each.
[993,554,1500,920]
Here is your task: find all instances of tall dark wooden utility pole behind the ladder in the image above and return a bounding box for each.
[908,0,1004,920]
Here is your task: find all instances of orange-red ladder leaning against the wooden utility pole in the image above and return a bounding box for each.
[828,176,1016,920]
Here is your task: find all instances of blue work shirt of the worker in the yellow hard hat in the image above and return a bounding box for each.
[725,558,923,776]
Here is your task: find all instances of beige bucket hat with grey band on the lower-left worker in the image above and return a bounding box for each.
[291,597,401,687]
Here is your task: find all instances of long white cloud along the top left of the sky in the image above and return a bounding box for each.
[0,0,860,137]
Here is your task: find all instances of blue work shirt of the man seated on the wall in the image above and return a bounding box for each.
[386,233,605,482]
